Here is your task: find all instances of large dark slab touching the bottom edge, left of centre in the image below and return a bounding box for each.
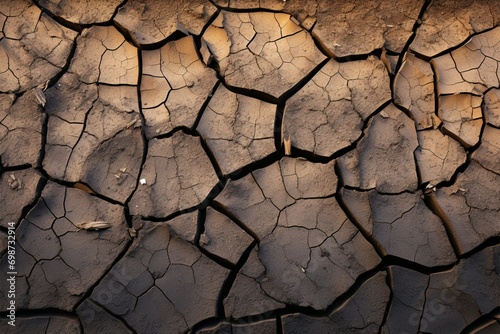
[89,225,229,333]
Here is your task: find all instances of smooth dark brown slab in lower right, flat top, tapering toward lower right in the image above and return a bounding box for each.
[342,189,456,267]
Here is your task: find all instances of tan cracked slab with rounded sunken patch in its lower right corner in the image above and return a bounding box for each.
[43,77,143,203]
